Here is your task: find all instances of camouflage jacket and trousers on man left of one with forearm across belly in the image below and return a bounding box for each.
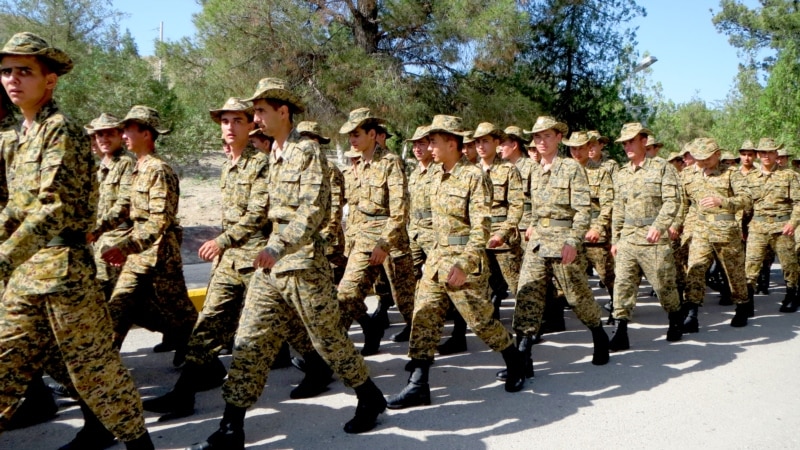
[611,158,680,320]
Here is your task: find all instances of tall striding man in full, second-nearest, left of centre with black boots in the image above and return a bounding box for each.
[191,78,386,450]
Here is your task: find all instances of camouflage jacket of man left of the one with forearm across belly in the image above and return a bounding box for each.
[611,158,680,245]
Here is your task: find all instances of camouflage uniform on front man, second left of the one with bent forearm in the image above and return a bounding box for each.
[513,156,601,336]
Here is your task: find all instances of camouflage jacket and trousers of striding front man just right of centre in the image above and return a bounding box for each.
[408,157,513,361]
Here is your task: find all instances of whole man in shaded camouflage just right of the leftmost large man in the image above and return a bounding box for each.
[101,105,197,367]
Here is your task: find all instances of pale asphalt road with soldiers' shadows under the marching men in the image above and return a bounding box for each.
[0,264,800,450]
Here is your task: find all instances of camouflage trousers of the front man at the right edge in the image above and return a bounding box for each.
[745,229,800,287]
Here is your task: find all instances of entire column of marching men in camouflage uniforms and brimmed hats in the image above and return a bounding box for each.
[0,33,800,449]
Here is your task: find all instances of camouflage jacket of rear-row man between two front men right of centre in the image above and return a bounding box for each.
[478,155,525,248]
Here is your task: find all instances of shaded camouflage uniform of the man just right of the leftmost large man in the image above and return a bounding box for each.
[108,154,197,345]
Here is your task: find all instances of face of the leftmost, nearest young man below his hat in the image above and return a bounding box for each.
[0,55,58,110]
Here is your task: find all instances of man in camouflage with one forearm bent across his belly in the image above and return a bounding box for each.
[681,138,753,326]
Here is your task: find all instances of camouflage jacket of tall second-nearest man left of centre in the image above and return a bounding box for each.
[267,129,331,273]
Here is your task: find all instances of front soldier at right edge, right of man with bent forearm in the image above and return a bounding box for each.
[745,138,800,312]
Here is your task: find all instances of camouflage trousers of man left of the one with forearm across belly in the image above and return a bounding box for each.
[614,240,681,320]
